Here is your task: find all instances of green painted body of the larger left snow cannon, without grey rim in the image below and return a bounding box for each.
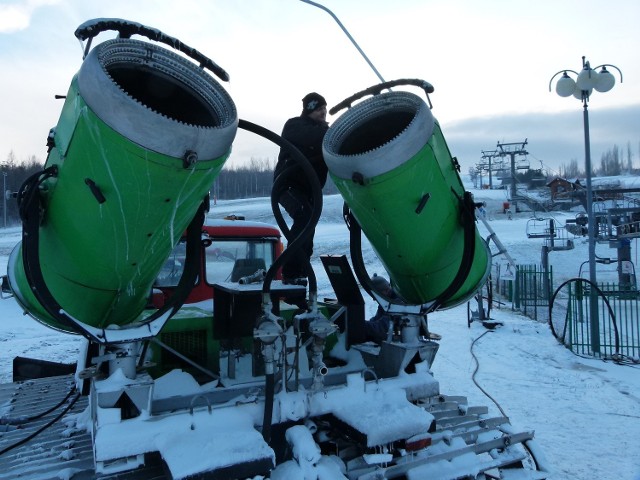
[11,86,226,327]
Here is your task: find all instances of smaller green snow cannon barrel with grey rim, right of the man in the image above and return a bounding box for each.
[323,91,491,308]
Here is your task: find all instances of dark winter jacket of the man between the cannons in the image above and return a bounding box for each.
[274,116,329,194]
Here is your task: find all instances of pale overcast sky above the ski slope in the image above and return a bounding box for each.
[0,0,640,173]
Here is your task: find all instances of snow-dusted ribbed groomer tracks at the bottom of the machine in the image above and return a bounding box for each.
[0,376,547,480]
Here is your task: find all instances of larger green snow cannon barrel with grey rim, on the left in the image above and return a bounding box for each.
[8,38,238,331]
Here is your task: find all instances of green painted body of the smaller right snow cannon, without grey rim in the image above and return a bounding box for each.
[330,102,490,307]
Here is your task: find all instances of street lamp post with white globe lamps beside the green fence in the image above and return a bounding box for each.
[549,57,622,353]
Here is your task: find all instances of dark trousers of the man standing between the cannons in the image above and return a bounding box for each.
[278,188,315,278]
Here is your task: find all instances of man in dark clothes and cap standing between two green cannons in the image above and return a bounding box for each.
[273,92,329,286]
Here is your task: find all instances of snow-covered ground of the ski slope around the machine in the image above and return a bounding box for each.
[0,190,640,480]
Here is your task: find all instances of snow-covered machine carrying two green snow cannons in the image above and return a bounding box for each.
[0,19,546,480]
